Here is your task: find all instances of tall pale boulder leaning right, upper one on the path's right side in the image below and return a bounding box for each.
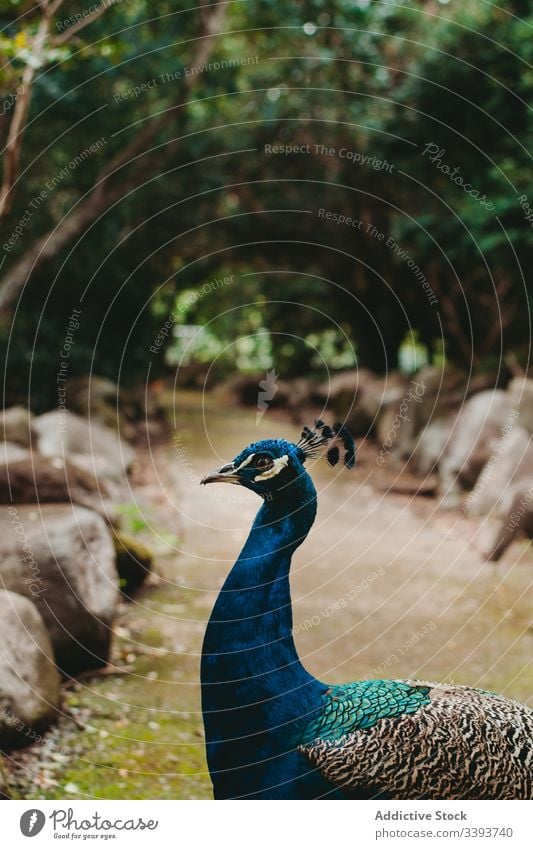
[439,389,513,505]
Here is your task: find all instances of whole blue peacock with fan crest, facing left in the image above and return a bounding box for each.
[201,420,533,800]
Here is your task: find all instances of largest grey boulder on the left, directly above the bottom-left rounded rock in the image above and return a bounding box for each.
[0,504,118,674]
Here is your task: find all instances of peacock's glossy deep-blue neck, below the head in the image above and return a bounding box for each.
[202,472,326,790]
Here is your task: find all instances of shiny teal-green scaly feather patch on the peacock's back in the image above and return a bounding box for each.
[303,680,429,744]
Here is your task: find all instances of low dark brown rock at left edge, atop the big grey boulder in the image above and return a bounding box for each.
[0,454,110,515]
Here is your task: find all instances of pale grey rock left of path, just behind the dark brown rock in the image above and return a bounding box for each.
[32,410,135,482]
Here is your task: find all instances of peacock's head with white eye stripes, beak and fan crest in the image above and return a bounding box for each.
[201,419,355,500]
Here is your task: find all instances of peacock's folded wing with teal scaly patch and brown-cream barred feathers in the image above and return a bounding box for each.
[299,681,533,799]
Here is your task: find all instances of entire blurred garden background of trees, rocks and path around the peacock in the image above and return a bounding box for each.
[0,0,533,798]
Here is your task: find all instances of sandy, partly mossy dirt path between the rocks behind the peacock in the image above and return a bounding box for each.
[5,394,533,799]
